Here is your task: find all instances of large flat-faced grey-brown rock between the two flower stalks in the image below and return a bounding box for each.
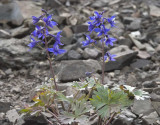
[56,59,101,82]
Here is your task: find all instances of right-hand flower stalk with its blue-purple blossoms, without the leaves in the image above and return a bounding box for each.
[82,11,117,84]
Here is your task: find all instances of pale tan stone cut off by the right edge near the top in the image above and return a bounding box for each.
[149,5,160,17]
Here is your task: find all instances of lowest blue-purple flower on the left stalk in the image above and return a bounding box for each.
[48,45,66,55]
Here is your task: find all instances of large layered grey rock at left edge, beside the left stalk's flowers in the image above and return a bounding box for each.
[0,36,45,68]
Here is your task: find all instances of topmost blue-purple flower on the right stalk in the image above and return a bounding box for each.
[90,11,102,26]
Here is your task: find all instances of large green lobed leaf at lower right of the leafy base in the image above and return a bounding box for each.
[90,86,131,118]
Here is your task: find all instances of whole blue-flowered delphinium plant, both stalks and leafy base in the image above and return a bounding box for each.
[21,9,149,125]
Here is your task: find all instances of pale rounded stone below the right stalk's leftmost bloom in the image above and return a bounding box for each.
[83,48,100,59]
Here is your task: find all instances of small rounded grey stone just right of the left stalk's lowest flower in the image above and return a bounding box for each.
[68,50,82,60]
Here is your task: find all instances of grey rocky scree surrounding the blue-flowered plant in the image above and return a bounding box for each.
[0,0,160,125]
